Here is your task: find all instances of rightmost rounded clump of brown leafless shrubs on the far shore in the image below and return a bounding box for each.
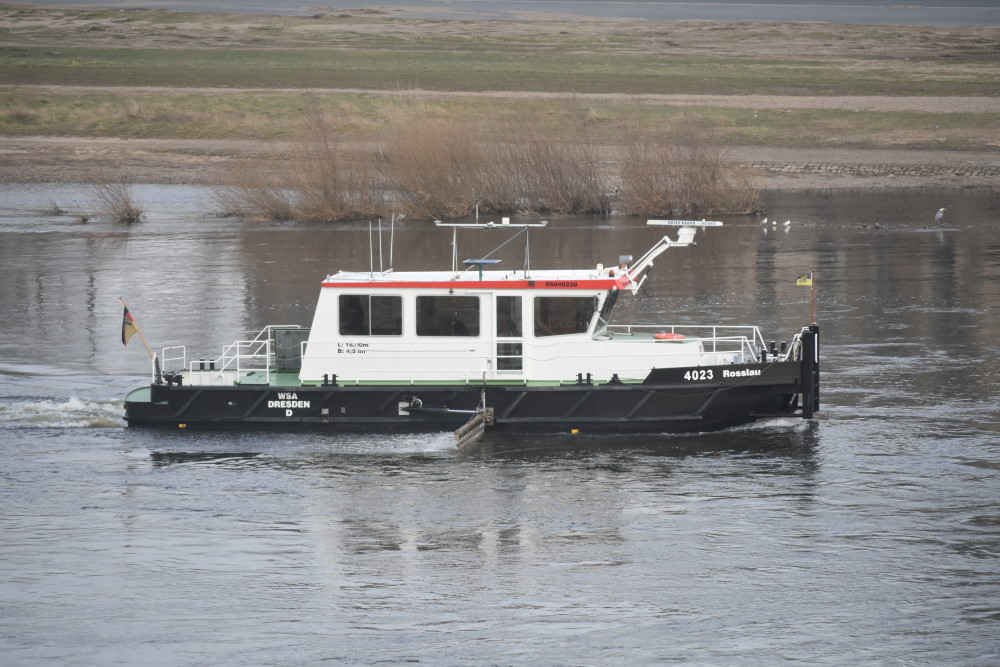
[621,122,757,216]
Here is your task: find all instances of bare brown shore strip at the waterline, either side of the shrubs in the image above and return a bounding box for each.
[0,137,1000,190]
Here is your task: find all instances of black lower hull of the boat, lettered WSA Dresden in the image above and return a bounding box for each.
[125,328,819,433]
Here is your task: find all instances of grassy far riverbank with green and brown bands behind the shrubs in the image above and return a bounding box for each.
[0,3,1000,189]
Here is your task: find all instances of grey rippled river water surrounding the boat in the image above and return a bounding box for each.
[0,185,1000,665]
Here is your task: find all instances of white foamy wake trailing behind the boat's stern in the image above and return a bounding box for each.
[0,397,124,429]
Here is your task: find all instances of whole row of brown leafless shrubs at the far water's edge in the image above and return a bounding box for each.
[216,101,757,221]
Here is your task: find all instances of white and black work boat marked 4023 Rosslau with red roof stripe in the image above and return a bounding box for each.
[125,219,820,434]
